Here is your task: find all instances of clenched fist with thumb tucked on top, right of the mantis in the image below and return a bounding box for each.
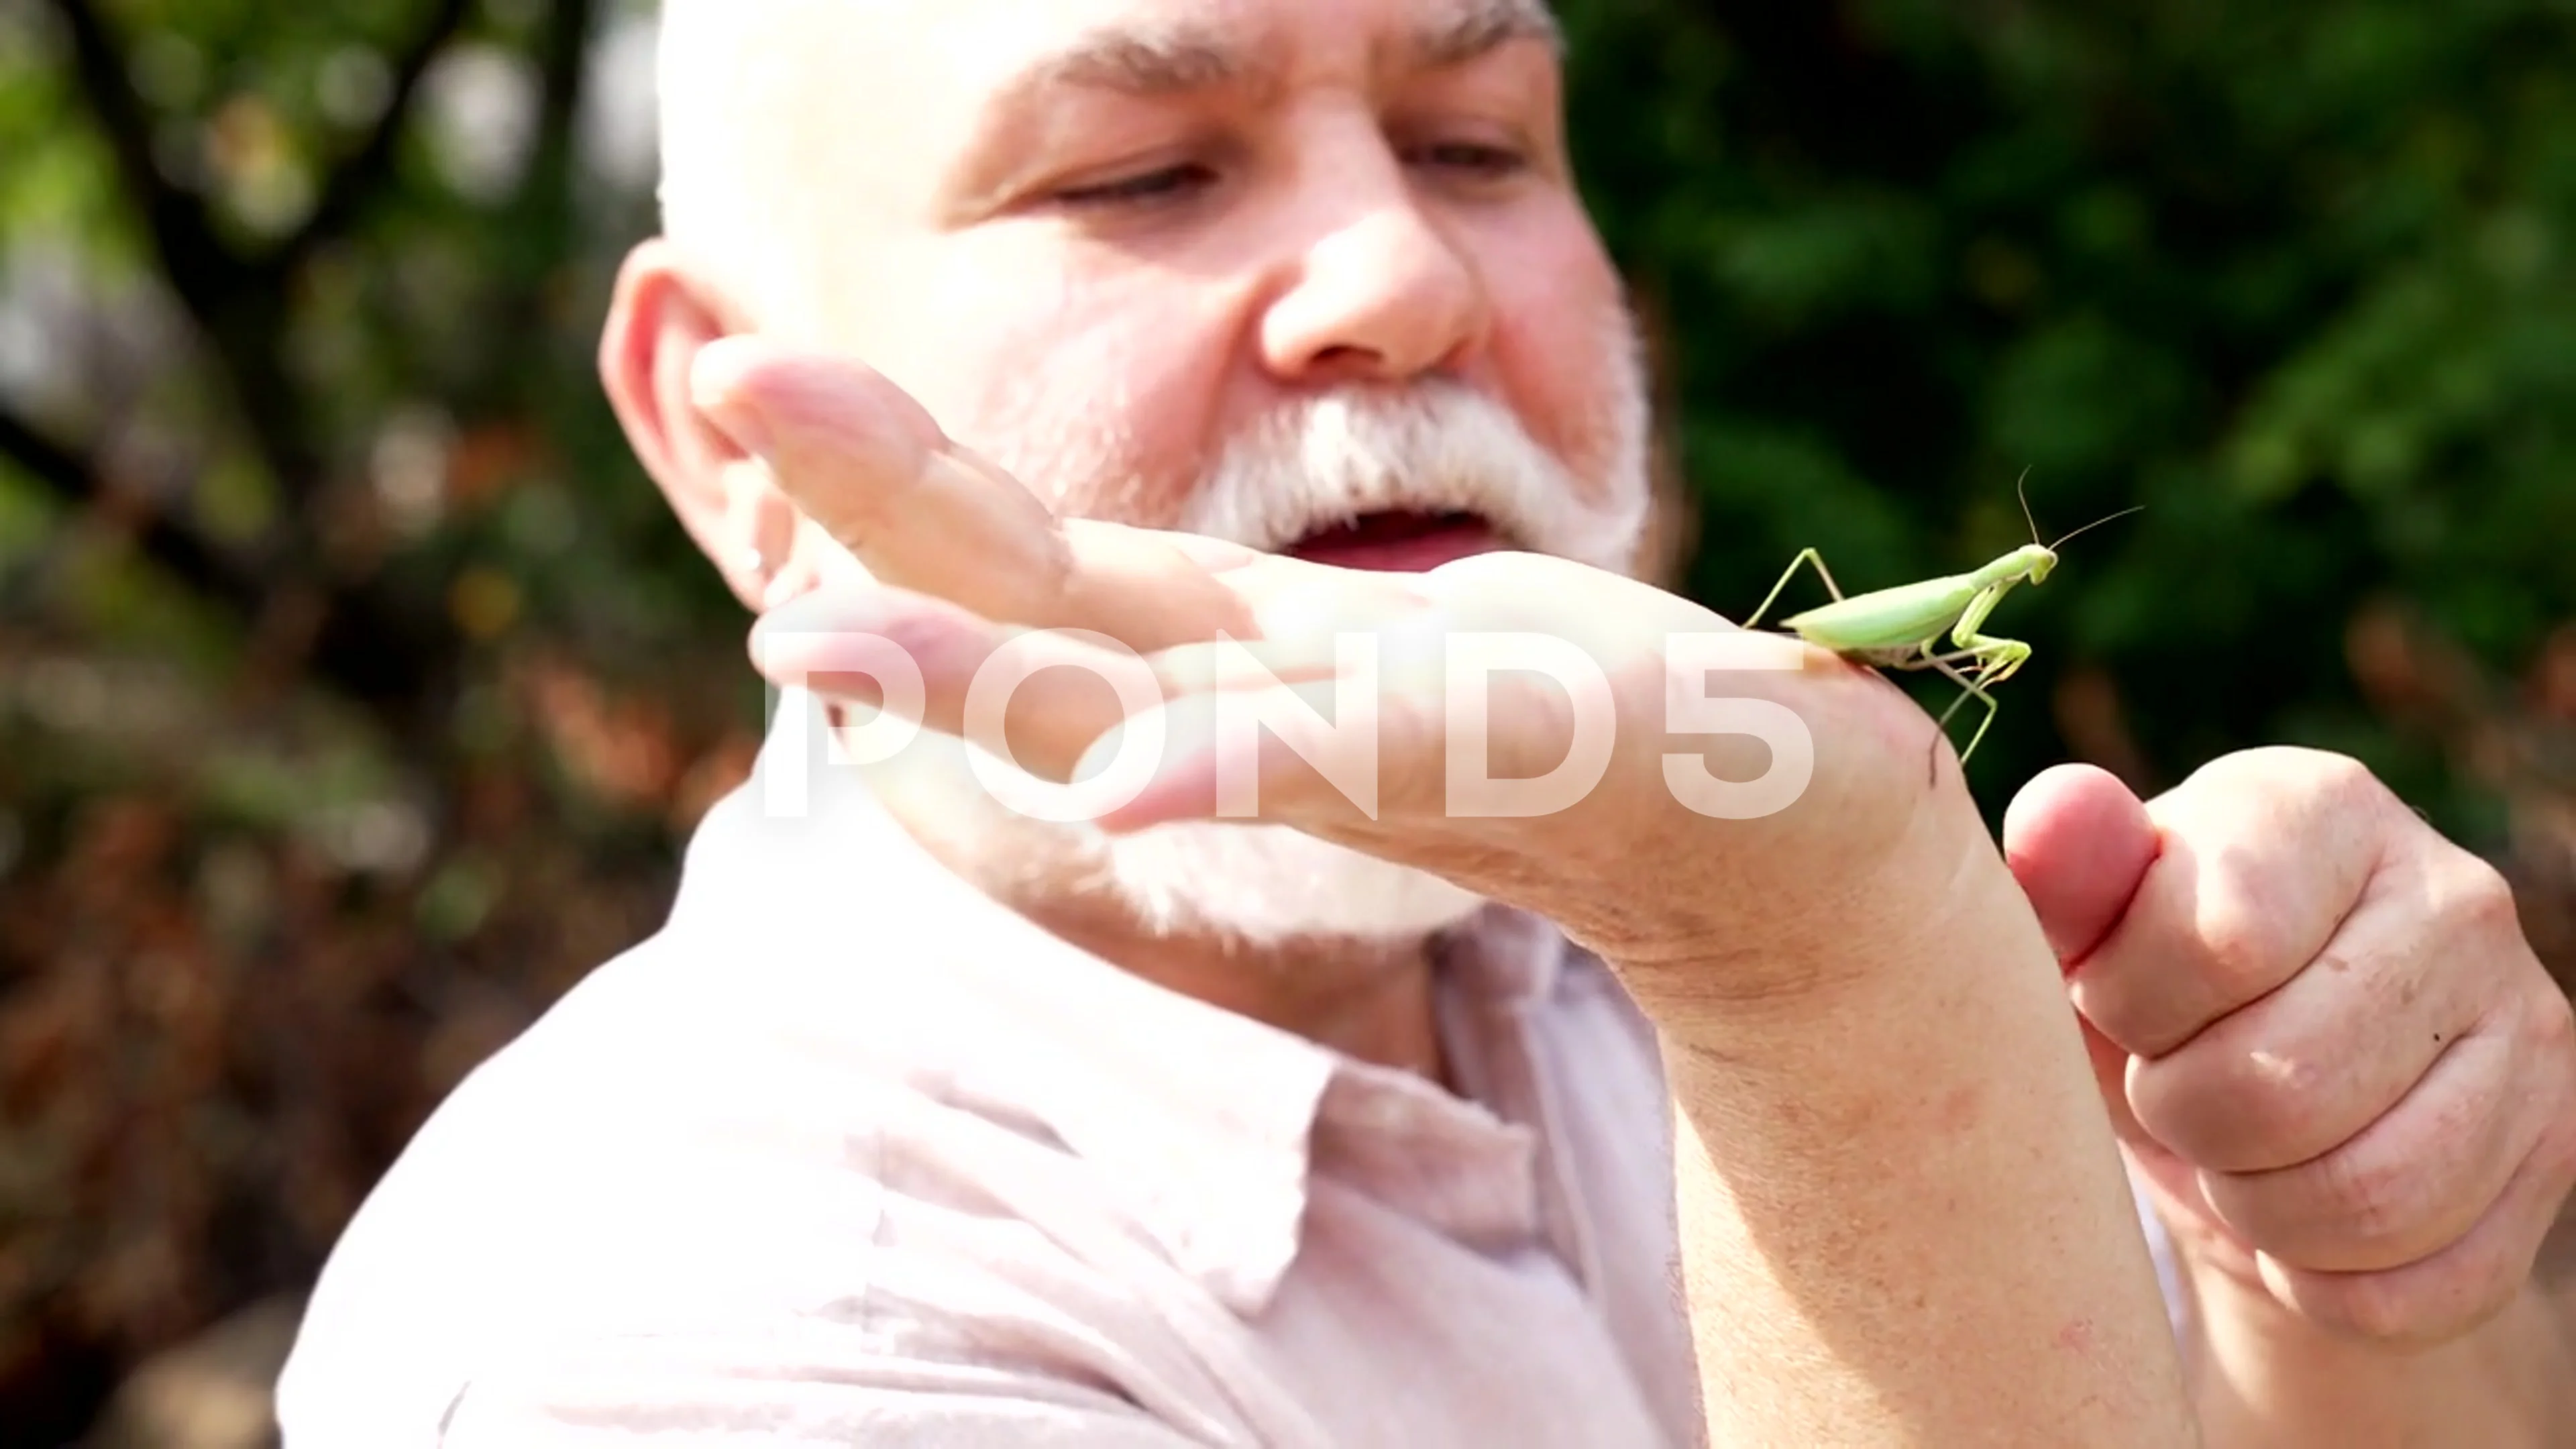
[2004,750,2576,1343]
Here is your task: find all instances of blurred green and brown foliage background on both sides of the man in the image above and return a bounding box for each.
[0,0,2576,1436]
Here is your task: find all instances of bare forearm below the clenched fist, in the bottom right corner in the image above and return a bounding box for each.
[2184,1274,2576,1449]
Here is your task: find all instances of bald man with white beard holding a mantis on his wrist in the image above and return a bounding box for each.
[281,0,2576,1449]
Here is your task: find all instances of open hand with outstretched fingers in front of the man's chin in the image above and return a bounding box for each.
[698,340,2009,1008]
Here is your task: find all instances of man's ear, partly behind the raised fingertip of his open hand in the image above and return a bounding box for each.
[600,237,796,611]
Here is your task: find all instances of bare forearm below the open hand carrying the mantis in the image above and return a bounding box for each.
[1659,804,2195,1446]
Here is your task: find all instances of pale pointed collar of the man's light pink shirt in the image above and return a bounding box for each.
[672,691,1561,1315]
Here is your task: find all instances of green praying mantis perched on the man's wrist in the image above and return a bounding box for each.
[1744,485,2143,776]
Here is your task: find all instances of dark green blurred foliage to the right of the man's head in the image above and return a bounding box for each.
[1561,0,2576,833]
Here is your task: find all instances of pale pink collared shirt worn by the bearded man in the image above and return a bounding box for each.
[278,696,1703,1449]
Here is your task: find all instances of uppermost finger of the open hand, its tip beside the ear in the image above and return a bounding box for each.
[690,335,1265,652]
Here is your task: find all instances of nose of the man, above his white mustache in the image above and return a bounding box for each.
[1263,157,1487,387]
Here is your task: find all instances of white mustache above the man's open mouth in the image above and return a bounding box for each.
[1180,382,1649,570]
